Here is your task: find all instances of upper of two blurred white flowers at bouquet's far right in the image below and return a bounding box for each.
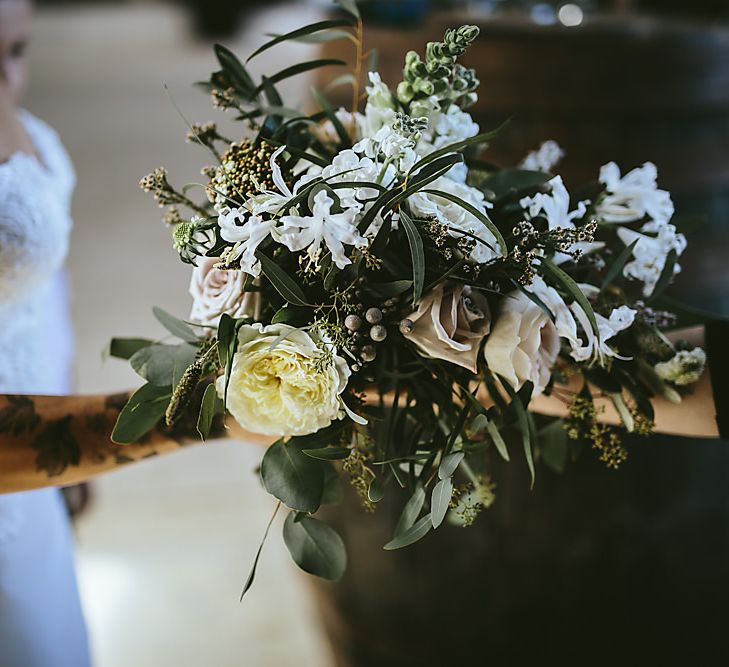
[595,162,673,224]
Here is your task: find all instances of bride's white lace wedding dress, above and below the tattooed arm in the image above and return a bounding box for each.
[0,111,89,667]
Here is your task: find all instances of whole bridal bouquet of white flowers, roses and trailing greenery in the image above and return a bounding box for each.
[112,2,705,585]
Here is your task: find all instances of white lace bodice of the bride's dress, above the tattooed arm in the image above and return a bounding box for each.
[0,111,75,393]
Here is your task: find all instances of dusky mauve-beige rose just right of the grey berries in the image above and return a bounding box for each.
[400,283,491,373]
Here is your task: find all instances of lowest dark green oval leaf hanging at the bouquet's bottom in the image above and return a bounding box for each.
[284,512,347,581]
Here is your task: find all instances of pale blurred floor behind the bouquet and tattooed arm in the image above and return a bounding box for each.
[27,3,336,667]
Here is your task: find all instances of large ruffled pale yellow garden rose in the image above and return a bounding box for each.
[217,322,350,436]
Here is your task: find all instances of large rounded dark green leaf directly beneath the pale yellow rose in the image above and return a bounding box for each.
[261,440,324,512]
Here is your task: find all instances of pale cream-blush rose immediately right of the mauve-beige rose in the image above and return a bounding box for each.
[483,291,560,396]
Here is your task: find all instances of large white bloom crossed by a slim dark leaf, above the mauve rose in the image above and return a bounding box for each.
[408,176,501,264]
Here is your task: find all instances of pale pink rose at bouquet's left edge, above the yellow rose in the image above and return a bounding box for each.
[190,257,261,326]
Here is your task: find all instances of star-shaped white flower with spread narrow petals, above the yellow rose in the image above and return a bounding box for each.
[276,190,368,269]
